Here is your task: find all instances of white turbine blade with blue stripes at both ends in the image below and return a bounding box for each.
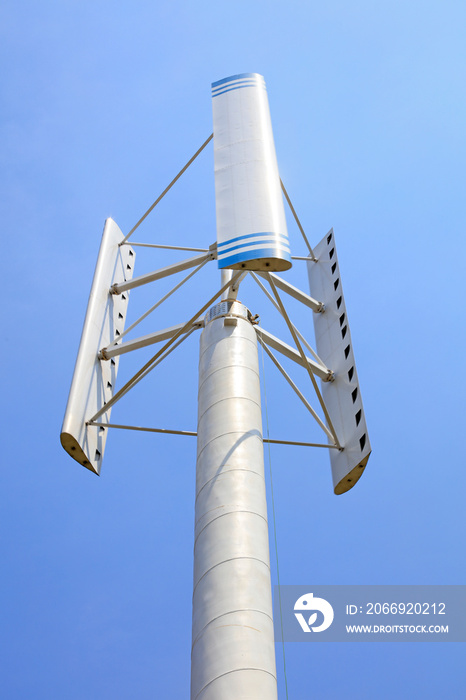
[212,73,291,271]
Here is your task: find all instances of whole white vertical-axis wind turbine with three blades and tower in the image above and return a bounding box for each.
[61,73,371,700]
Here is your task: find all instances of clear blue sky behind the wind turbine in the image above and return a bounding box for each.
[0,0,466,700]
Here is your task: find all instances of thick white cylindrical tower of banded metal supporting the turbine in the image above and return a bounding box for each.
[191,301,277,700]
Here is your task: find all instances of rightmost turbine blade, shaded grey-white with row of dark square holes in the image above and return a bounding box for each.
[308,229,371,494]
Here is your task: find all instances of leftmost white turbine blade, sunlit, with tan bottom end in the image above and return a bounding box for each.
[60,219,135,474]
